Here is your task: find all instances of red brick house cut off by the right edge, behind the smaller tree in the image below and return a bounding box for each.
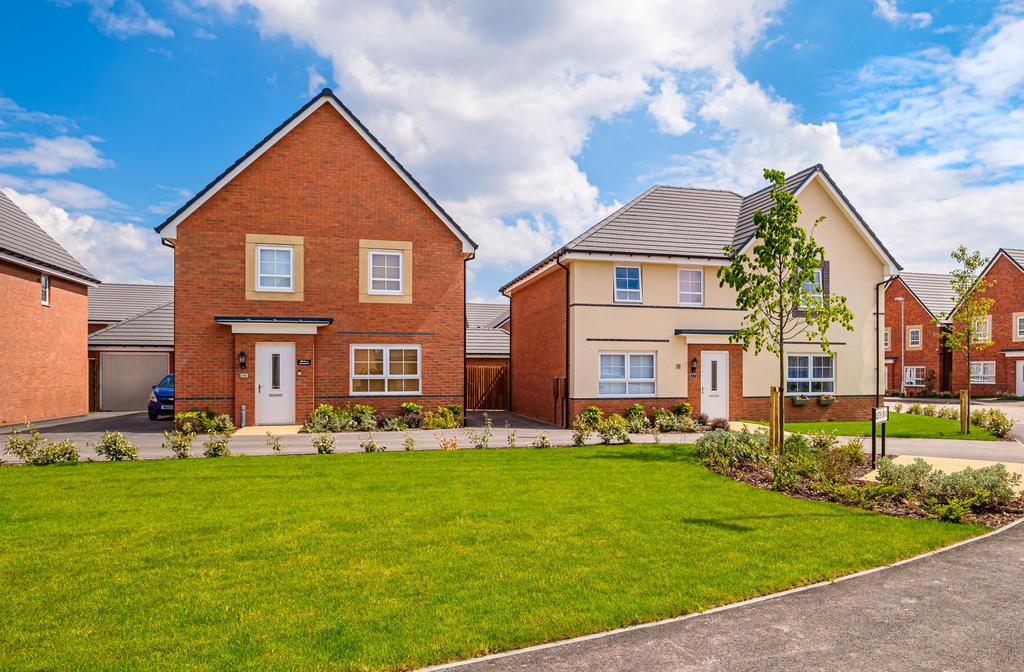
[952,248,1024,395]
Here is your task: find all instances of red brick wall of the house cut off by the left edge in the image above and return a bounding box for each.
[0,261,89,425]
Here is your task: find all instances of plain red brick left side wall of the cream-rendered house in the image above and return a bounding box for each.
[510,267,566,424]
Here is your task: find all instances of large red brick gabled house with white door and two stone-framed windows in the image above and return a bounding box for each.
[157,89,476,425]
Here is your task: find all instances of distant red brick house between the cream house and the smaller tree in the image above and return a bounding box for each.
[882,272,954,395]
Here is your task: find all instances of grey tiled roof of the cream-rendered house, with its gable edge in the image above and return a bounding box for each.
[500,164,902,292]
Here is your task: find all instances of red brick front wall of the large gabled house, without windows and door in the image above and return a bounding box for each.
[174,100,465,424]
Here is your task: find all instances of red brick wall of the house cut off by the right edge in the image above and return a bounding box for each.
[952,254,1024,394]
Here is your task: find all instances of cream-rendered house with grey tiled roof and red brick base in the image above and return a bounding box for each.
[501,165,900,425]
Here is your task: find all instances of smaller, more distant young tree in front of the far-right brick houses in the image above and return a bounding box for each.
[936,245,995,433]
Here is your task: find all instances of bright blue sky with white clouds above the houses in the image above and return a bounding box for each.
[0,0,1024,301]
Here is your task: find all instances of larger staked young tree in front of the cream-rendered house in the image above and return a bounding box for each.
[718,168,854,452]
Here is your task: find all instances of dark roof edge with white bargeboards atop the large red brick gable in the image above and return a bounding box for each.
[156,88,477,253]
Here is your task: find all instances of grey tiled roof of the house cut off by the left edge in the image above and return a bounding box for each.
[0,192,99,285]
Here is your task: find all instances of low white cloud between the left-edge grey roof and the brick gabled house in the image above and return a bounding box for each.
[3,188,173,283]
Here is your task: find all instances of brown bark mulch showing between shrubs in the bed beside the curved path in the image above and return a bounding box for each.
[719,455,1024,530]
